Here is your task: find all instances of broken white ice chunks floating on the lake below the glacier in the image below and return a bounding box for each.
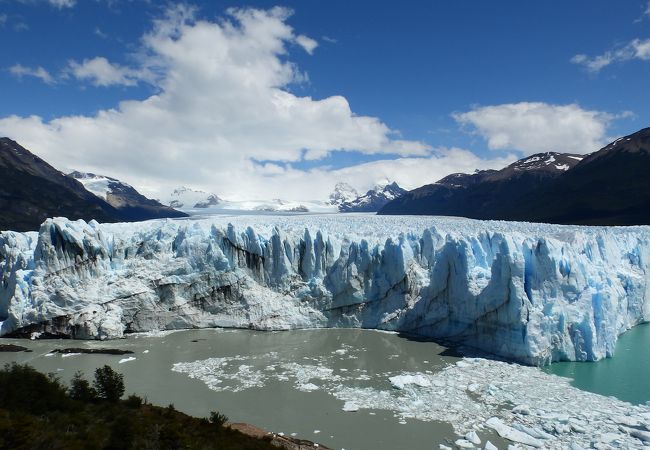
[173,353,650,450]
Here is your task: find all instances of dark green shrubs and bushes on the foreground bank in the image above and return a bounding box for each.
[0,363,277,450]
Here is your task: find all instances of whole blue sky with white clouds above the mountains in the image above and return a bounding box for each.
[0,0,650,200]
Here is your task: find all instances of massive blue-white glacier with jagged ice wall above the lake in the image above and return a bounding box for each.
[0,215,650,364]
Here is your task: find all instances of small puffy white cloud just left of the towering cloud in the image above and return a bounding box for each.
[68,56,143,86]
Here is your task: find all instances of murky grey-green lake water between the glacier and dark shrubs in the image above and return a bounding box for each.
[0,329,507,450]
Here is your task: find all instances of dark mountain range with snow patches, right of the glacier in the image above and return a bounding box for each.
[379,128,650,225]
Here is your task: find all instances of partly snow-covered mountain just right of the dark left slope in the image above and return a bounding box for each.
[68,171,186,220]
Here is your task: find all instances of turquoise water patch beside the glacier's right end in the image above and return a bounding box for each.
[544,323,650,404]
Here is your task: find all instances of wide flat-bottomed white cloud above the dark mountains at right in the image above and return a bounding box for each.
[453,102,612,154]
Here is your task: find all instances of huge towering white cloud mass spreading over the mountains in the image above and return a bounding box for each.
[0,7,512,199]
